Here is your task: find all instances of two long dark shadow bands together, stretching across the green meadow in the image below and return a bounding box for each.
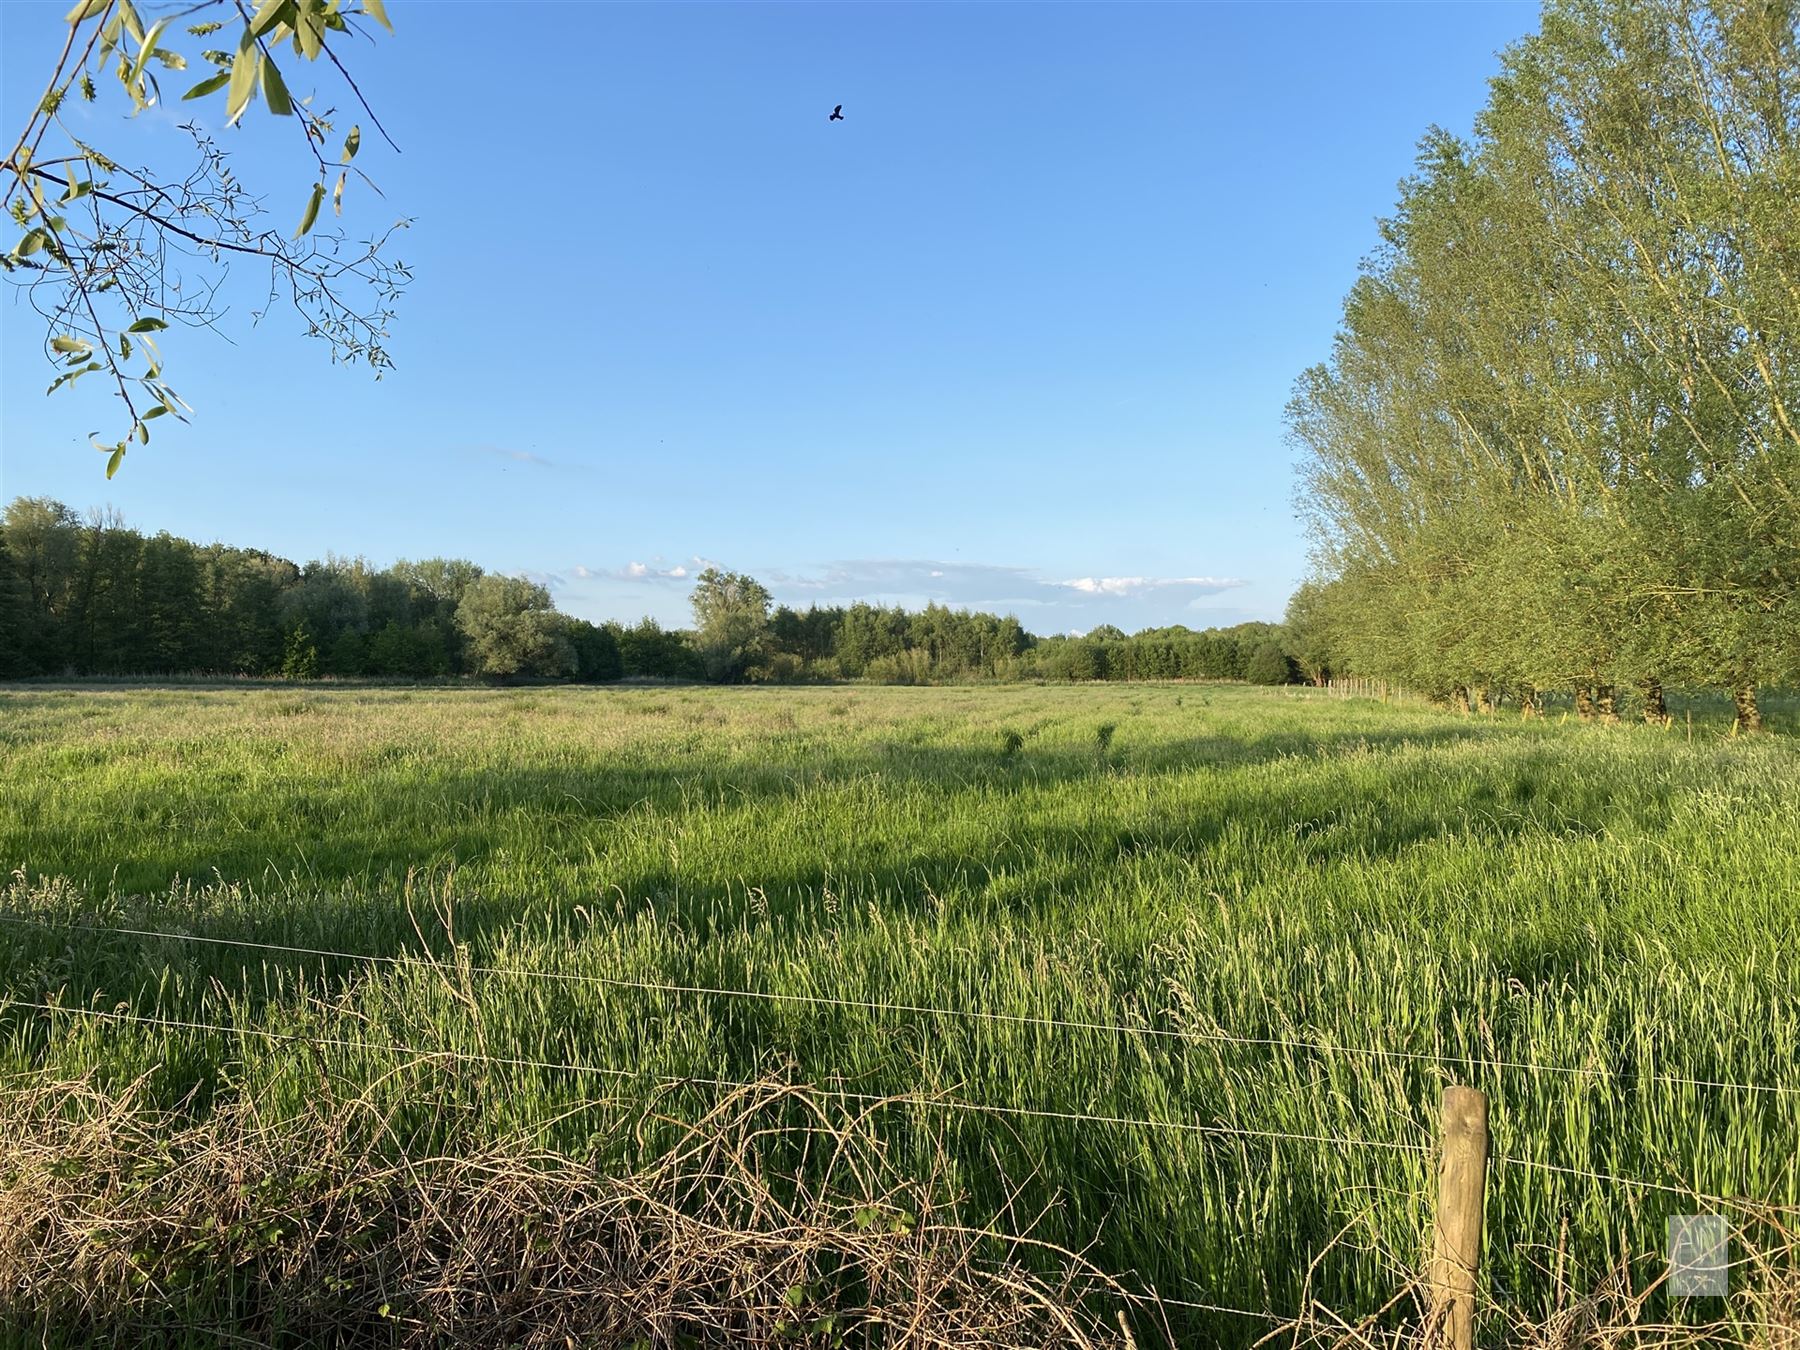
[0,724,1660,1044]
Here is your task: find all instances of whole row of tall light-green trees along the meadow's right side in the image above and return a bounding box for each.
[1287,0,1800,729]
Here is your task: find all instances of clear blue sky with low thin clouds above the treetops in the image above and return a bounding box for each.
[0,0,1537,632]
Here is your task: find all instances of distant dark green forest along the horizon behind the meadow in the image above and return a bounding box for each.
[0,497,1321,684]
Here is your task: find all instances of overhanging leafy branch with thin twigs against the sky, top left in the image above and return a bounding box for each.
[0,0,410,477]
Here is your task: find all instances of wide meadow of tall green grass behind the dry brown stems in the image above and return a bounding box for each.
[0,686,1800,1343]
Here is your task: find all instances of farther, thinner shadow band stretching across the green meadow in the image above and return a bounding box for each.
[20,724,1487,895]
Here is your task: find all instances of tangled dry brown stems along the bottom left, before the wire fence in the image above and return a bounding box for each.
[0,1082,1129,1350]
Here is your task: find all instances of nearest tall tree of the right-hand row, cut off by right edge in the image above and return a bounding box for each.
[1508,0,1800,725]
